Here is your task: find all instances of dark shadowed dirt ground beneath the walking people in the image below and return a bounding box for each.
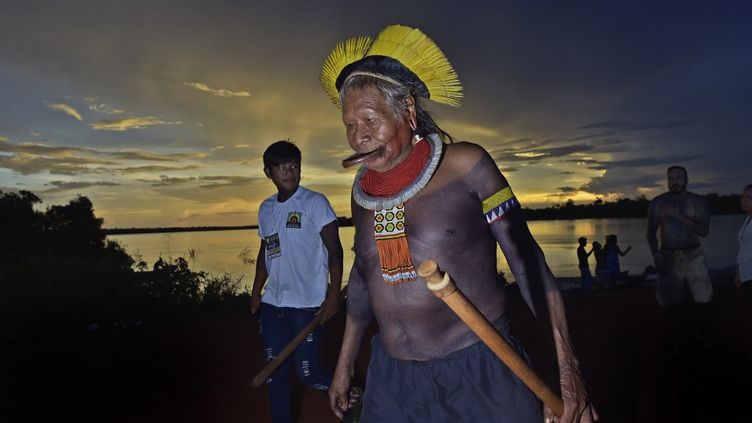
[0,280,752,423]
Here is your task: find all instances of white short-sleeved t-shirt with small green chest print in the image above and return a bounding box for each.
[258,186,337,308]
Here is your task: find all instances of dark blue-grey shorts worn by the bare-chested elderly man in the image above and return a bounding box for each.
[360,335,543,423]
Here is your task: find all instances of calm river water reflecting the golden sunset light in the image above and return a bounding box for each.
[108,215,744,292]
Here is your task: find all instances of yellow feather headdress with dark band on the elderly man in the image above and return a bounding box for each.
[320,25,462,107]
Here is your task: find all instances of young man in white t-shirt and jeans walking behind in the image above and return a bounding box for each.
[251,141,343,423]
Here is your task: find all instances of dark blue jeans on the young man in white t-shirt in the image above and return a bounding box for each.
[259,303,332,423]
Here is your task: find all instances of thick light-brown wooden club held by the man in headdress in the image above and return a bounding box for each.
[418,260,564,416]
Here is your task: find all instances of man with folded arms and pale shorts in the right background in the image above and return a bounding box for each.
[647,166,713,355]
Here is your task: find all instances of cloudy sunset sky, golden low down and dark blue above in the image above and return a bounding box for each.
[0,0,752,227]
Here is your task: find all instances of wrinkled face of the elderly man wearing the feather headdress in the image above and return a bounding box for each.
[342,87,412,172]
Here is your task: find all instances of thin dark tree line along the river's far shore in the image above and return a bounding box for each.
[103,193,742,235]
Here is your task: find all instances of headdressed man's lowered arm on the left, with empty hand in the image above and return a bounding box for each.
[329,258,373,419]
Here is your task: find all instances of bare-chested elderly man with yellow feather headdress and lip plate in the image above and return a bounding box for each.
[321,25,597,422]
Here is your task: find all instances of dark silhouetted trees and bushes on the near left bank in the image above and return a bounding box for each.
[0,191,247,344]
